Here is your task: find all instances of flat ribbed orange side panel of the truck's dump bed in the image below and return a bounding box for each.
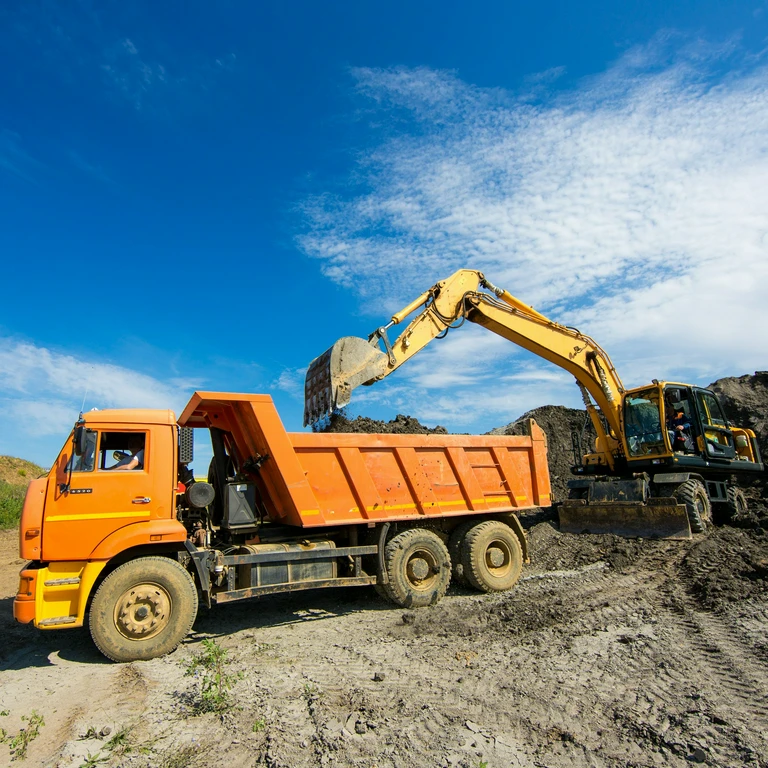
[289,433,550,525]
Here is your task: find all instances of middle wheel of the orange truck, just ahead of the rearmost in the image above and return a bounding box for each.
[381,528,451,608]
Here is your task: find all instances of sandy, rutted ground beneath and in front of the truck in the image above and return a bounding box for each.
[0,521,768,768]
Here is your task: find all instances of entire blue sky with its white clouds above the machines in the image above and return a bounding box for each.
[0,0,768,465]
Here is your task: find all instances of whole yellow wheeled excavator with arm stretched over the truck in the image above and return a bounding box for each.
[304,269,764,538]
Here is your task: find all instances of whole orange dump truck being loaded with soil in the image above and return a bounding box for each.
[13,392,550,661]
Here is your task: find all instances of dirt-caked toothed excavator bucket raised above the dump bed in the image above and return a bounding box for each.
[304,336,388,427]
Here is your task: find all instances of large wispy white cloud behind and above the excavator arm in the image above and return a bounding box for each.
[298,34,768,426]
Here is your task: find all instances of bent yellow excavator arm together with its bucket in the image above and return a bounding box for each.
[304,269,624,468]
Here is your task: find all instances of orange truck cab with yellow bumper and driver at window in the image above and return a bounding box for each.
[14,409,187,629]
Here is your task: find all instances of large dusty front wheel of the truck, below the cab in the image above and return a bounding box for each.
[88,556,197,661]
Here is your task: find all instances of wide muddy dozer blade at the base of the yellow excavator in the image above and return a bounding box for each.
[558,497,692,539]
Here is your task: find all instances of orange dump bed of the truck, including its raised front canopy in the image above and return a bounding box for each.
[179,392,551,528]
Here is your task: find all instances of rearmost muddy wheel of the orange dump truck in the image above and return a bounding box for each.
[462,520,523,592]
